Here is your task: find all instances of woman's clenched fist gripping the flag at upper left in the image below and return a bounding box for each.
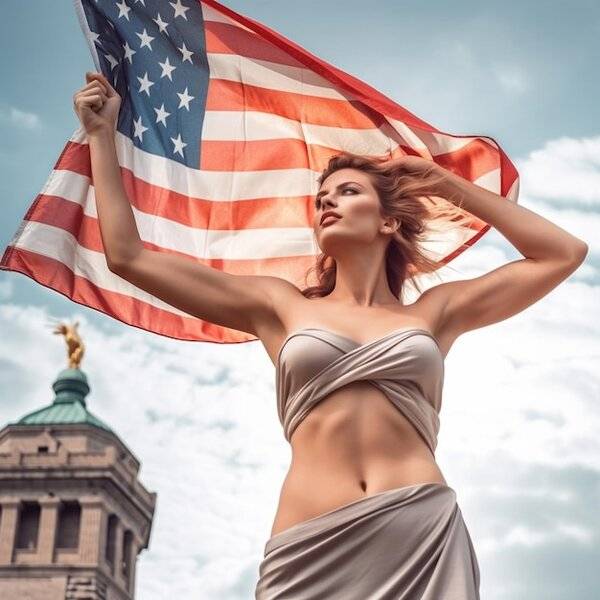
[73,72,121,135]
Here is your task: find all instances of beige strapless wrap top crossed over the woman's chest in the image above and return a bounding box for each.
[276,327,444,454]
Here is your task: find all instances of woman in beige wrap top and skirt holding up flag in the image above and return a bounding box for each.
[74,73,587,600]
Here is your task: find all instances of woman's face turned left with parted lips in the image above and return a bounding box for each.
[313,168,384,256]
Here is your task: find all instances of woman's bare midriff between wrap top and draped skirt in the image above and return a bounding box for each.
[271,381,446,536]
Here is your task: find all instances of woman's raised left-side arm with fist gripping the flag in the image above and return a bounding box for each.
[74,73,298,335]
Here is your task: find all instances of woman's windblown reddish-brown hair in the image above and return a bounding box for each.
[301,152,472,299]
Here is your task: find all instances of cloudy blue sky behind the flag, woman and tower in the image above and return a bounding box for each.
[0,0,600,600]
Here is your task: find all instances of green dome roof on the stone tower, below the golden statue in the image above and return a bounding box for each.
[15,369,114,433]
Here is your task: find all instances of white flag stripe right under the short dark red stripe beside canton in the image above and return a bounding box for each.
[206,52,355,102]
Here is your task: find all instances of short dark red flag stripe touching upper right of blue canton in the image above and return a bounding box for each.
[204,21,305,68]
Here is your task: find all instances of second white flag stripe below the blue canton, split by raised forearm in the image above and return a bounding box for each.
[45,171,317,260]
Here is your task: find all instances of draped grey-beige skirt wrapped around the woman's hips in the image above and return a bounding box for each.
[255,483,479,600]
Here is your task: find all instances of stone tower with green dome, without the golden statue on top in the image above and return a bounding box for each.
[0,368,156,600]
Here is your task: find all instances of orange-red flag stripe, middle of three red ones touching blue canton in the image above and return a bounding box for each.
[206,78,384,129]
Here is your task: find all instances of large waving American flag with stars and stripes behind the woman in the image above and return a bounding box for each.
[0,0,519,343]
